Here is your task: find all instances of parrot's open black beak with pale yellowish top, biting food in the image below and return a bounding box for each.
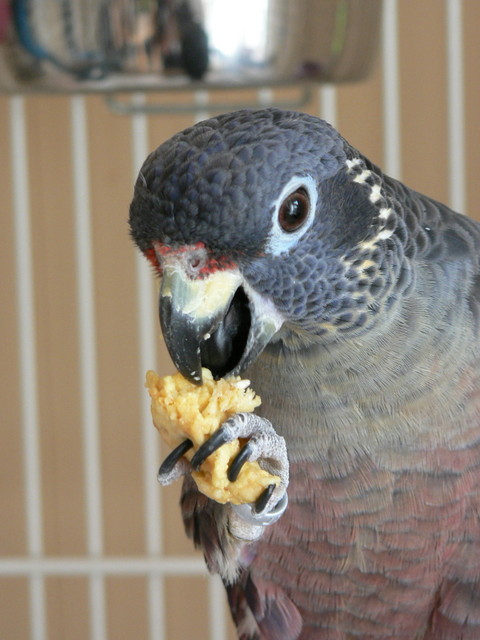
[159,265,281,384]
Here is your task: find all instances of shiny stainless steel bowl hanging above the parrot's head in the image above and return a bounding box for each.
[0,0,381,92]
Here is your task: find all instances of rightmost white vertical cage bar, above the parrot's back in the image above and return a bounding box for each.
[445,0,466,213]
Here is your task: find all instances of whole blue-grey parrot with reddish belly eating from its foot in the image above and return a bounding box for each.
[129,107,480,640]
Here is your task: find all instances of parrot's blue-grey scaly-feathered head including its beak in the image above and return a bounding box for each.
[130,109,410,383]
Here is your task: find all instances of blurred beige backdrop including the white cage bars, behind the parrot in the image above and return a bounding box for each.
[0,0,480,640]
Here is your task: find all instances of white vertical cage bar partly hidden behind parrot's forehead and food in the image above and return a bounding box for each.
[131,94,166,640]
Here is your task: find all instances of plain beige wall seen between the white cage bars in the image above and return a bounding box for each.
[0,0,480,640]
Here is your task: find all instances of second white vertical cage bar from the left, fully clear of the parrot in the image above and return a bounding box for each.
[70,96,106,640]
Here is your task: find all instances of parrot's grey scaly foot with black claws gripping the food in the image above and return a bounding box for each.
[191,413,289,526]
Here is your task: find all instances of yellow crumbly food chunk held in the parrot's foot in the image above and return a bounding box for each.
[145,369,280,504]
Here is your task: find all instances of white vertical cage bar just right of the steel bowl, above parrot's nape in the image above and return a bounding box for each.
[382,0,402,179]
